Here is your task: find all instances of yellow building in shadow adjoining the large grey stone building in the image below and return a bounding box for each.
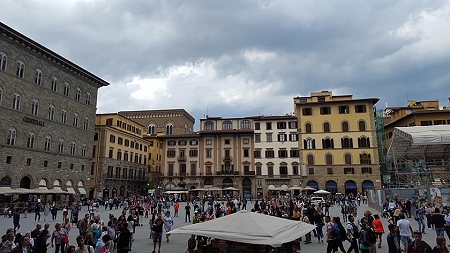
[90,113,153,198]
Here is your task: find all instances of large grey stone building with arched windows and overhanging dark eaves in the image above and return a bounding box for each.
[0,23,109,195]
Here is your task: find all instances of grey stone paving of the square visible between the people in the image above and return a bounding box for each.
[0,202,442,253]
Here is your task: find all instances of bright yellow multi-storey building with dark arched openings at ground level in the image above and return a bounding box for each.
[294,91,381,194]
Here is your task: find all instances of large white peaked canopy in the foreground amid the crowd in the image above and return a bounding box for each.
[168,210,316,247]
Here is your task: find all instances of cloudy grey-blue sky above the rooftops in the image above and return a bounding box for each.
[0,0,450,126]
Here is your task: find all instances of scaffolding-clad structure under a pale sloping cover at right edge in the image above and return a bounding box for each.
[386,125,450,188]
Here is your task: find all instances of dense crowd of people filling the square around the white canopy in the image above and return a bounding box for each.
[0,195,450,253]
